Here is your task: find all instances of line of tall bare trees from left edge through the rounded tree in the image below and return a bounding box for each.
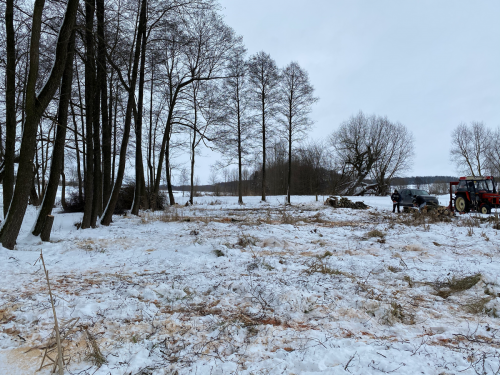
[0,0,420,248]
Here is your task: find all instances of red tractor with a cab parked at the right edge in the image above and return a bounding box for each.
[450,176,500,214]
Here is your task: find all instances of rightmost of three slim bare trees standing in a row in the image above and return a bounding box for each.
[277,62,319,203]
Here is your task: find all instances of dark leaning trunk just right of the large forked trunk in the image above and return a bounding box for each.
[32,31,75,236]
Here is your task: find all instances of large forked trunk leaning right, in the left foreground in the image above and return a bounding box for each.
[0,0,78,249]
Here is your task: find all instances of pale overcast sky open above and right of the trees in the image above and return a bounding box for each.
[191,0,500,182]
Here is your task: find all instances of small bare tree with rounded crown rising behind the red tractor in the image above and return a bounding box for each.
[450,122,493,176]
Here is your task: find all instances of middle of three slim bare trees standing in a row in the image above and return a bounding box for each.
[249,52,280,201]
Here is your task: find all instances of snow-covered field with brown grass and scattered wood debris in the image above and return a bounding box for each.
[0,194,500,375]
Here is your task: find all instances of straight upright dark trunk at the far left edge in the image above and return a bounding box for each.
[3,0,16,217]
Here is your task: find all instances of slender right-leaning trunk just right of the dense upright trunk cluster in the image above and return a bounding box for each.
[101,0,146,225]
